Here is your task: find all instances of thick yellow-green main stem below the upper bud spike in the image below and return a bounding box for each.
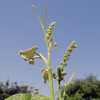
[47,48,54,100]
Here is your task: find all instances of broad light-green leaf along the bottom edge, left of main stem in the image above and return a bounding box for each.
[5,93,50,100]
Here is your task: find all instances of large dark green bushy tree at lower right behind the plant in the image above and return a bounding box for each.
[61,74,100,100]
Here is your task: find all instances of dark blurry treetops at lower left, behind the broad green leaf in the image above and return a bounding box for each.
[0,80,38,100]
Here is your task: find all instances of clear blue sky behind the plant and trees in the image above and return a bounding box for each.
[0,0,100,97]
